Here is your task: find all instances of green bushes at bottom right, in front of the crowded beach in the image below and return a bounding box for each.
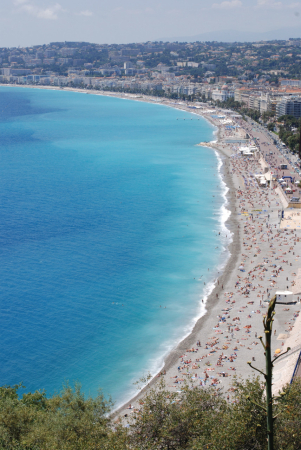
[125,378,301,450]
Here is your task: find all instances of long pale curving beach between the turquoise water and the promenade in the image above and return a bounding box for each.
[1,82,301,418]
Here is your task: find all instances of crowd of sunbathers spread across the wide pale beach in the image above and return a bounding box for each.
[121,106,300,418]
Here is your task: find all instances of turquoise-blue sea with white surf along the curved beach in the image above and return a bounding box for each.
[0,86,230,407]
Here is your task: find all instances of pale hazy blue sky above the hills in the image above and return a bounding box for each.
[0,0,301,47]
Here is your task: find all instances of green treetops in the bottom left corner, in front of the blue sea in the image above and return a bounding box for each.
[0,385,110,450]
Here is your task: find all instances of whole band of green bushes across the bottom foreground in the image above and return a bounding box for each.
[0,379,301,450]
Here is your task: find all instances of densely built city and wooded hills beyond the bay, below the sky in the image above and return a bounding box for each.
[0,39,301,117]
